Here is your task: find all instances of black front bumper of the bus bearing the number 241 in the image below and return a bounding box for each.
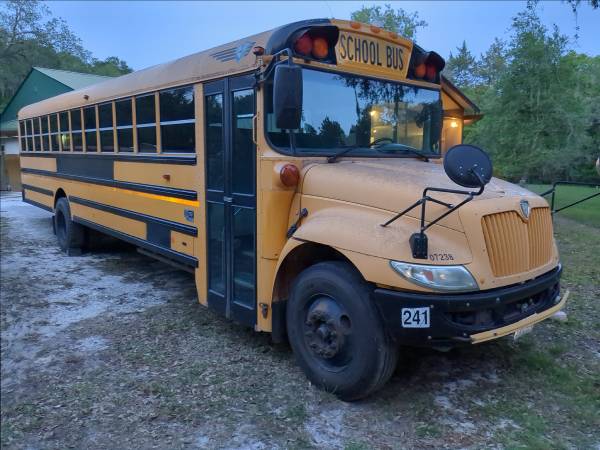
[372,266,566,347]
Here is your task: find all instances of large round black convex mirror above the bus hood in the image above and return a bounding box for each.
[444,144,492,188]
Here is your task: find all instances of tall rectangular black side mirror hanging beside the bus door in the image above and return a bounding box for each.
[273,64,302,130]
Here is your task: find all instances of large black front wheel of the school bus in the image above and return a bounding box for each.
[286,261,398,401]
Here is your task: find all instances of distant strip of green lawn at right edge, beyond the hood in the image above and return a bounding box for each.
[526,184,600,228]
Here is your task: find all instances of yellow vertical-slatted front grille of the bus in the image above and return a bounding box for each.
[482,208,552,277]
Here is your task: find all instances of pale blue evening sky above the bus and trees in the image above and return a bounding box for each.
[47,0,600,70]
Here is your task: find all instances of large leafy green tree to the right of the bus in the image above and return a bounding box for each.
[467,5,600,182]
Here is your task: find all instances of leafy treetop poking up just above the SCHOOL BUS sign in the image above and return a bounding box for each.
[351,4,427,40]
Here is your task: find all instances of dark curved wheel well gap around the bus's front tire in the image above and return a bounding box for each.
[271,242,354,342]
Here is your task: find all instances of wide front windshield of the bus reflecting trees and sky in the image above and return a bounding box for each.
[267,69,442,156]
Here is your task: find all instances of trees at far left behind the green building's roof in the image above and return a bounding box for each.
[0,0,131,110]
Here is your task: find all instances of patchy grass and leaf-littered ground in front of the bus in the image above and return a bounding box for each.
[0,192,600,450]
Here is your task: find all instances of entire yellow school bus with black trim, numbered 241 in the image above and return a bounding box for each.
[19,19,566,400]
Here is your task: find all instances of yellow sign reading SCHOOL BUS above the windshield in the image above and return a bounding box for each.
[336,30,412,78]
